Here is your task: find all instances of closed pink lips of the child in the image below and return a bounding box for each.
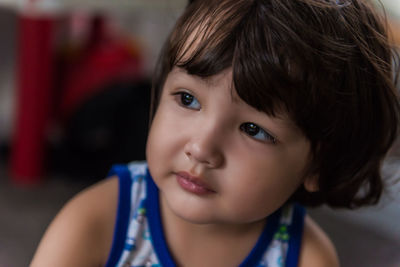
[175,172,215,195]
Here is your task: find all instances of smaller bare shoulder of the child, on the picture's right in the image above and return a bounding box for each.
[299,216,340,267]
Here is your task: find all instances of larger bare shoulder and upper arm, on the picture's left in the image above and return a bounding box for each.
[30,177,118,267]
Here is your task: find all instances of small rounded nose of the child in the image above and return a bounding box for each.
[184,123,224,168]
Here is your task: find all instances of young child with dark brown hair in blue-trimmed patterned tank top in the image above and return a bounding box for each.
[31,0,400,267]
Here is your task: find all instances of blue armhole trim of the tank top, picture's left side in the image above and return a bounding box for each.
[105,165,132,267]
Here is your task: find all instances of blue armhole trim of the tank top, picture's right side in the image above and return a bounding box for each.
[286,204,306,267]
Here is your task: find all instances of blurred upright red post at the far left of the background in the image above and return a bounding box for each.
[11,16,54,184]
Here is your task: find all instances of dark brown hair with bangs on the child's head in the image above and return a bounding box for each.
[152,0,400,208]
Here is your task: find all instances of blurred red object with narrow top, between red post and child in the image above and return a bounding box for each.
[59,16,142,119]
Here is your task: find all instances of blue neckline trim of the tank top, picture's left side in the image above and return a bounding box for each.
[145,169,176,267]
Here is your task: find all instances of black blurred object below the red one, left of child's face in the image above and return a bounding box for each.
[49,81,150,179]
